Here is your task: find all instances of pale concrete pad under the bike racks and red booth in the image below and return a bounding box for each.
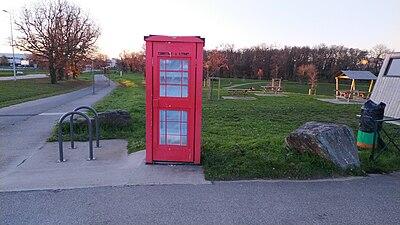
[0,140,210,191]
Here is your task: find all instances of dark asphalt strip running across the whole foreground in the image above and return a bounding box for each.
[0,174,400,224]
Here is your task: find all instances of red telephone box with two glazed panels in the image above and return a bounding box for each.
[144,35,204,164]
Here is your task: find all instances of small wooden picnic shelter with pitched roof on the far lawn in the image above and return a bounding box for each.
[335,70,377,101]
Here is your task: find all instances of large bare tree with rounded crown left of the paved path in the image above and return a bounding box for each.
[16,0,100,84]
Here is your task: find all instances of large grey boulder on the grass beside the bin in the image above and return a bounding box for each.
[285,122,360,169]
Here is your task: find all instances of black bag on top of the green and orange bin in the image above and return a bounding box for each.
[359,100,386,133]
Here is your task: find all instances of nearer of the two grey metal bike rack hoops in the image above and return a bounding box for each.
[58,111,94,162]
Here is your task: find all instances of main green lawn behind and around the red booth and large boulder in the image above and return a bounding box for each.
[53,74,400,180]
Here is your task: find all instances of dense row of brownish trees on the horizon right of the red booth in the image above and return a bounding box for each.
[205,44,393,82]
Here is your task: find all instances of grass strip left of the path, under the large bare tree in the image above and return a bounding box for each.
[0,78,91,107]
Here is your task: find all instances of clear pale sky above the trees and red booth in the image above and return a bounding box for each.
[0,0,400,57]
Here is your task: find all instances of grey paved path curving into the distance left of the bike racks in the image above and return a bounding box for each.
[0,75,115,177]
